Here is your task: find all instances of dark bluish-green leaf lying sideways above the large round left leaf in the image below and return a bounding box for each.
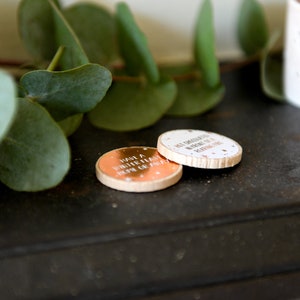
[20,64,112,121]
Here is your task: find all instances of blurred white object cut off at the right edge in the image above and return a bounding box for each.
[284,0,300,107]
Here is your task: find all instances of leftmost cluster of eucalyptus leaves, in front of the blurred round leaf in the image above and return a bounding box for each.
[0,0,112,191]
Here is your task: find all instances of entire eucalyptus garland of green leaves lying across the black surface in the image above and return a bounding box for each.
[0,0,283,191]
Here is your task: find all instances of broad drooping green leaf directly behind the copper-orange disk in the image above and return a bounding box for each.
[88,78,177,131]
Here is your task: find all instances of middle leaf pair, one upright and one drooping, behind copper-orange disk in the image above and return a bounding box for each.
[89,3,177,131]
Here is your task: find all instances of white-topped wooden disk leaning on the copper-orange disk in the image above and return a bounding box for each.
[157,129,242,169]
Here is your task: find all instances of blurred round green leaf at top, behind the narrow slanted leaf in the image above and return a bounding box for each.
[63,3,118,65]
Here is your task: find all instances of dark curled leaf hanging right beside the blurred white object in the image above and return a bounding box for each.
[260,31,285,102]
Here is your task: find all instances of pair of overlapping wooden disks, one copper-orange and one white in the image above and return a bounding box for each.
[96,129,242,192]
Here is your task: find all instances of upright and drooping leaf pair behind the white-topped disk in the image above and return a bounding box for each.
[162,0,225,116]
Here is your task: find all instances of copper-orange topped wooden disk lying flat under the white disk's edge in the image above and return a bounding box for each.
[96,147,182,192]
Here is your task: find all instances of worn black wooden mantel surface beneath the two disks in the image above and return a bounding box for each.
[0,65,300,300]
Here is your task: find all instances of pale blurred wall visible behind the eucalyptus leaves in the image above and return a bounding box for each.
[0,0,286,61]
